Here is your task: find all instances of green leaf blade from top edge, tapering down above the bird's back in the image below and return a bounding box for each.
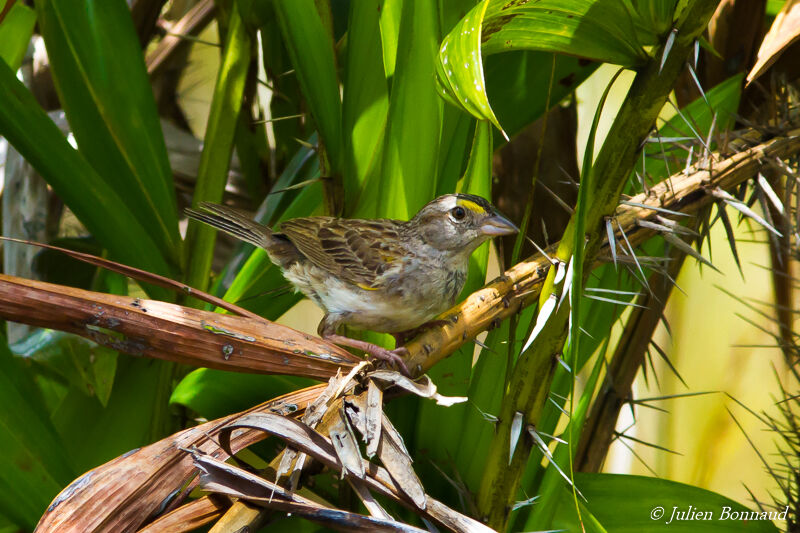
[274,0,343,172]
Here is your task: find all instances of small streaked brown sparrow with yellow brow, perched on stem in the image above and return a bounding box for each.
[186,194,519,374]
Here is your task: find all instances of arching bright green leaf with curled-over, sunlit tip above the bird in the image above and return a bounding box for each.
[437,0,648,125]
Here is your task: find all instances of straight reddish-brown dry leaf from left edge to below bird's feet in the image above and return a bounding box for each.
[0,275,362,380]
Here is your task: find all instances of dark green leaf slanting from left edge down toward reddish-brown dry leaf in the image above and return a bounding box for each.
[0,62,174,300]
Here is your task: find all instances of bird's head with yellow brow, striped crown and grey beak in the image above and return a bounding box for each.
[410,194,519,253]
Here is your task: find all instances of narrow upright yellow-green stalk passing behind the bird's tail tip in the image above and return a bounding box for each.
[186,3,251,290]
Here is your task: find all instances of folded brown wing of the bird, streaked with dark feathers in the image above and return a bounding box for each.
[280,217,408,290]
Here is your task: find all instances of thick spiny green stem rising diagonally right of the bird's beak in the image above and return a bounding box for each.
[478,0,718,531]
